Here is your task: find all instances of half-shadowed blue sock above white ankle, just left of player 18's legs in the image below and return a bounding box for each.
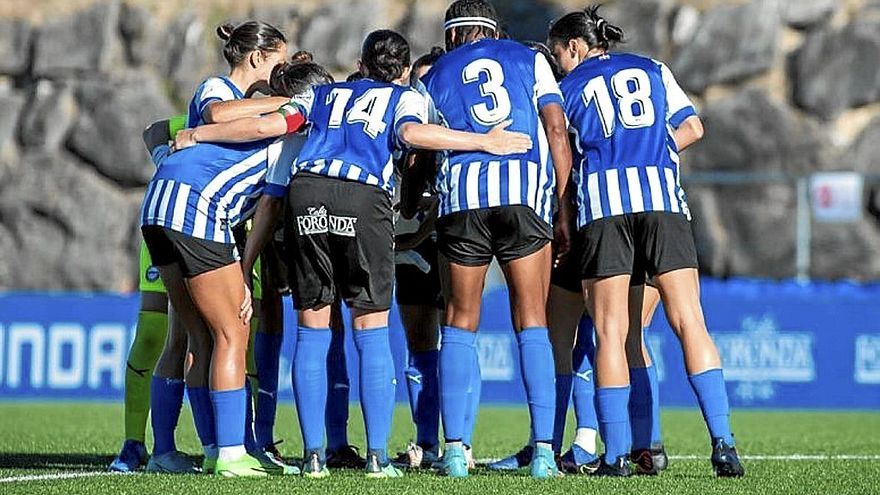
[572,316,599,430]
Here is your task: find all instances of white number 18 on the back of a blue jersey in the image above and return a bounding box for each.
[582,69,656,138]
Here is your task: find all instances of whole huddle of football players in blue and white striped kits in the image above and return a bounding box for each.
[110,0,744,479]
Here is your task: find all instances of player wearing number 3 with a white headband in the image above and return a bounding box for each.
[423,0,571,478]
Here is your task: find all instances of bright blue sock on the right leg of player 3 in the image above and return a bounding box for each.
[516,327,556,444]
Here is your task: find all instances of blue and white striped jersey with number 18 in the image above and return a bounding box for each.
[561,53,696,228]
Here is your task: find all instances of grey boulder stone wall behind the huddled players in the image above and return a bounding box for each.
[0,0,880,291]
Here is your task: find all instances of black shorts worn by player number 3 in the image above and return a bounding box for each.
[437,205,553,266]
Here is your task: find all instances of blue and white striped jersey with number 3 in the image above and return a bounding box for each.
[422,39,562,224]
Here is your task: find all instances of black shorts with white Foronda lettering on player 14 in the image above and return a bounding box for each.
[284,172,394,311]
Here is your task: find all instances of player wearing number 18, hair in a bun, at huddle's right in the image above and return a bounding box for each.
[549,3,743,476]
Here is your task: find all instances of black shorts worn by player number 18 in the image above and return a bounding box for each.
[578,212,699,285]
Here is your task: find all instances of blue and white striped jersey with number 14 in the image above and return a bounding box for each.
[281,79,427,194]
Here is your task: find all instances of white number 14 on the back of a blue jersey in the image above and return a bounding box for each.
[327,87,394,139]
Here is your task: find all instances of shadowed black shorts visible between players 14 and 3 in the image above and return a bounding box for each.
[394,239,446,309]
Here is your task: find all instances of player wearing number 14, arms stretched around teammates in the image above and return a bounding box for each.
[178,30,531,477]
